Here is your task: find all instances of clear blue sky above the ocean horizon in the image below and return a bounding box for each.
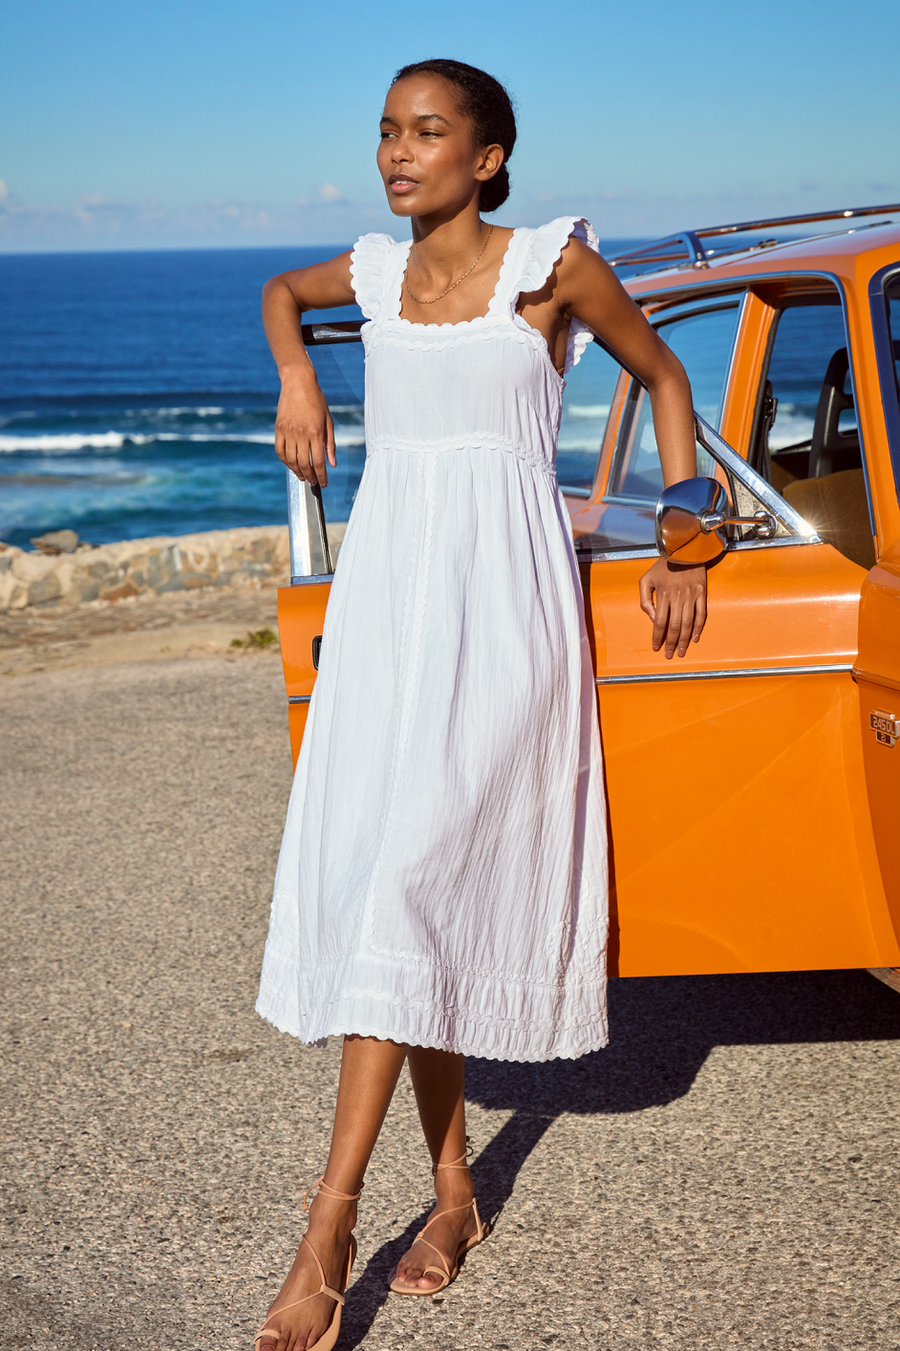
[0,0,900,251]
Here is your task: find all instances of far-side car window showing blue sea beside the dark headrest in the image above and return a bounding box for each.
[768,304,855,453]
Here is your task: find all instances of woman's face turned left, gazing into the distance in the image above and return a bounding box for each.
[378,74,503,216]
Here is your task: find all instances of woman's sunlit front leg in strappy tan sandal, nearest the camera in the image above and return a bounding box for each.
[259,1036,407,1351]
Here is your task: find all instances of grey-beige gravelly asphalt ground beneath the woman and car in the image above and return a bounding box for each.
[0,653,900,1351]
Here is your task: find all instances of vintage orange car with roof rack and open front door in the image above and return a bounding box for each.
[278,205,900,975]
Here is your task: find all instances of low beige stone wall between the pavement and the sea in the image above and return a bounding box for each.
[0,526,289,612]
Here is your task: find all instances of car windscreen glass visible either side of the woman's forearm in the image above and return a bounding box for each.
[614,303,739,501]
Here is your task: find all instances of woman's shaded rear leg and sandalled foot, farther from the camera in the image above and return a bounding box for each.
[397,1046,476,1290]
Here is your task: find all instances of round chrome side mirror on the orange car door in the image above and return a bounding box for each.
[657,478,777,563]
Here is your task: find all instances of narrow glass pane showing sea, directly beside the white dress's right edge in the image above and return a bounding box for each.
[557,342,622,492]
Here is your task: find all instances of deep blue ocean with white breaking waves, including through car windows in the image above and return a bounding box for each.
[0,240,830,546]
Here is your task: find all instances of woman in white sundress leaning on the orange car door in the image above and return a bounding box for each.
[250,61,705,1351]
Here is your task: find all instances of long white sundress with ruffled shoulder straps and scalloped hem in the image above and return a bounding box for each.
[257,218,608,1061]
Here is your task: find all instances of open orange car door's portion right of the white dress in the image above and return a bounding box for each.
[580,417,900,975]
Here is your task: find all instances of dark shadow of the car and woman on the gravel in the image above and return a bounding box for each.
[341,971,900,1351]
